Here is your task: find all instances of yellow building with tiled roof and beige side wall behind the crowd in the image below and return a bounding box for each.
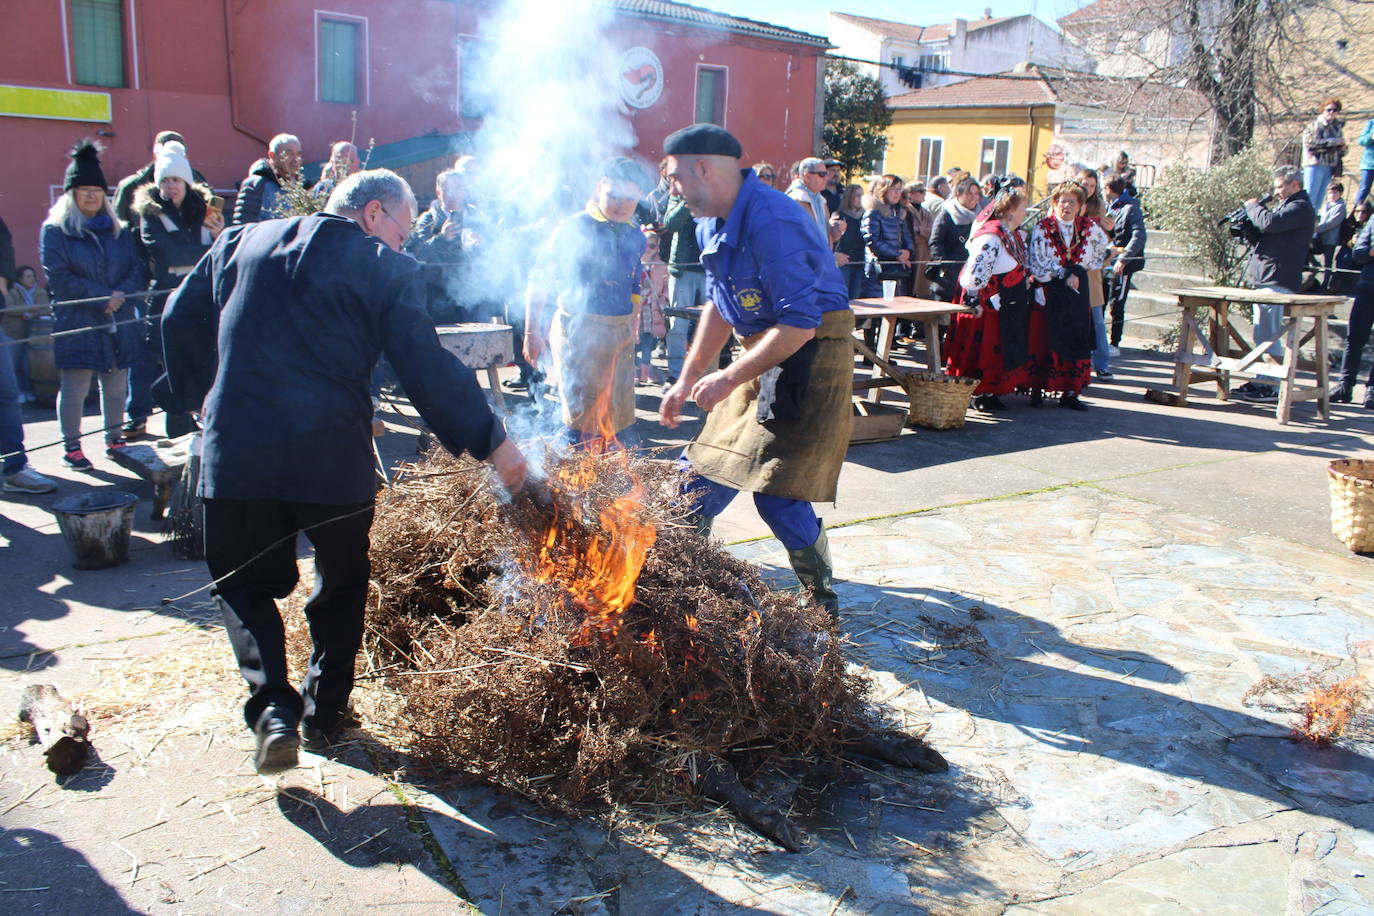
[883,65,1212,198]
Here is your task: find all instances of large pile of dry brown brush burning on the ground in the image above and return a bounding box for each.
[367,450,943,808]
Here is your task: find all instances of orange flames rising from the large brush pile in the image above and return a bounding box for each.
[529,342,657,637]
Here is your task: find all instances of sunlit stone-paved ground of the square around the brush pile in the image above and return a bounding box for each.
[0,347,1374,916]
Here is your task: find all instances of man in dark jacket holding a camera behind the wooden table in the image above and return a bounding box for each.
[1232,165,1316,401]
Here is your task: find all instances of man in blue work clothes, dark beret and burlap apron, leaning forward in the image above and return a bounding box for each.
[660,124,853,614]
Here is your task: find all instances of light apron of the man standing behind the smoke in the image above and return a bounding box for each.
[548,309,635,434]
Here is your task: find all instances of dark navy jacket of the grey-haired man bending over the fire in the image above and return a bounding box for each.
[154,214,506,504]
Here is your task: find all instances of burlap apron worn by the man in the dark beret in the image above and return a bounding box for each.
[686,309,855,503]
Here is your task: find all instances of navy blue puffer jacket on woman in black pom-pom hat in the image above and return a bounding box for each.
[40,217,148,372]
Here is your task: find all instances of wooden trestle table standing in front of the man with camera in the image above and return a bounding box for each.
[1148,286,1345,423]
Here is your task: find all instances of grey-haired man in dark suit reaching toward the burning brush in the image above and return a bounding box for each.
[158,169,525,773]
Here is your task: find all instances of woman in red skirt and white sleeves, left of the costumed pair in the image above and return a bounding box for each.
[948,188,1031,411]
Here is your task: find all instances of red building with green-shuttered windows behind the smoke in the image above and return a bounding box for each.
[0,0,829,264]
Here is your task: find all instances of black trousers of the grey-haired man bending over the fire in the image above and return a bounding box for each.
[205,500,372,731]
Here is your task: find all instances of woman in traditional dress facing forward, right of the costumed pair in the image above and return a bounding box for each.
[1028,181,1112,411]
